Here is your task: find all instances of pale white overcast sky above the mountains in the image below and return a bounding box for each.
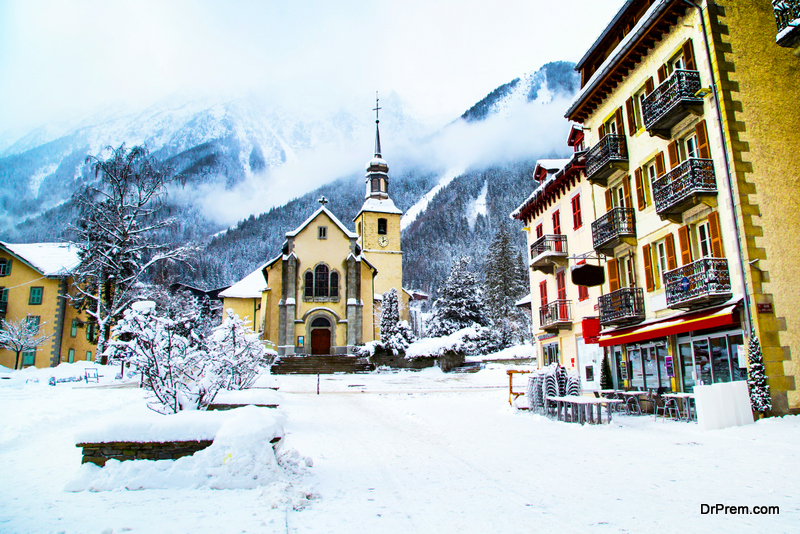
[0,0,623,132]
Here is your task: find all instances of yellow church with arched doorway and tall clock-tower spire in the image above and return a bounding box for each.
[220,105,410,356]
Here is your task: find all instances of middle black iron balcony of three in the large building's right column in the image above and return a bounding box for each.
[653,158,717,222]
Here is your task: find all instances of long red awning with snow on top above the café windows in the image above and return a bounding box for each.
[600,304,736,347]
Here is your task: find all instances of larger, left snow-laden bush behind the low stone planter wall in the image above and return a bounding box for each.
[111,301,210,414]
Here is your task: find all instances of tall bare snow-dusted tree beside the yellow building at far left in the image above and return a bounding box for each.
[72,145,192,360]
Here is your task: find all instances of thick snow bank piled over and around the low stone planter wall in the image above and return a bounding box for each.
[65,406,312,494]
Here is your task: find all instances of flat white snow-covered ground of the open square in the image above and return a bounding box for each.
[0,365,800,533]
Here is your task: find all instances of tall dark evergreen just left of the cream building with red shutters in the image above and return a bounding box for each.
[484,222,529,346]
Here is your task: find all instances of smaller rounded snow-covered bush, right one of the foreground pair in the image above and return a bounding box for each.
[206,309,276,394]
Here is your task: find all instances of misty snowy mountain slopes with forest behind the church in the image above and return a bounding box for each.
[0,62,579,298]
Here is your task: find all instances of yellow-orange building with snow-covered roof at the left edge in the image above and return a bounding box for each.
[0,243,96,368]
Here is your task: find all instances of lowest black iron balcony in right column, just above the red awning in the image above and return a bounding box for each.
[664,258,731,308]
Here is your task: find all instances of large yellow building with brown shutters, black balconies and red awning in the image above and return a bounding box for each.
[566,0,800,413]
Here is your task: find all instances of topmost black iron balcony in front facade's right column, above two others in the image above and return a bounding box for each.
[642,69,703,139]
